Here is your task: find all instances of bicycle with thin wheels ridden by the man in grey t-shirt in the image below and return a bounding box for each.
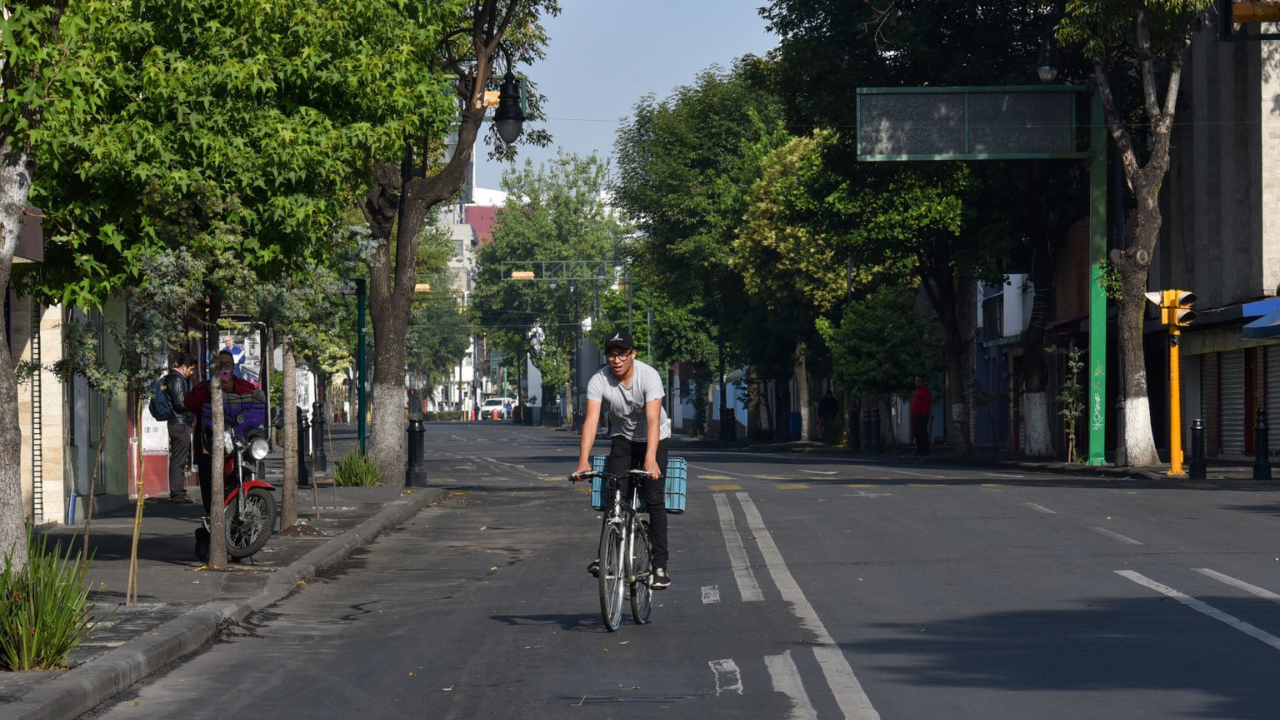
[570,470,653,633]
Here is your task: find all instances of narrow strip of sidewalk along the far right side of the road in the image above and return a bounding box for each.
[672,436,1280,486]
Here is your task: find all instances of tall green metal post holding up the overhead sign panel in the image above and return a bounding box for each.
[1085,87,1124,465]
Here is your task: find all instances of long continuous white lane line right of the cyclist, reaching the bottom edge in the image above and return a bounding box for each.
[736,492,879,720]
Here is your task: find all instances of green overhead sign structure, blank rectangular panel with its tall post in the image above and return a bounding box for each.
[858,85,1107,465]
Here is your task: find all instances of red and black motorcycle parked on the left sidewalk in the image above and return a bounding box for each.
[196,392,275,562]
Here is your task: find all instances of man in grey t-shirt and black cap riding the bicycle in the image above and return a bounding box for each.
[573,331,671,591]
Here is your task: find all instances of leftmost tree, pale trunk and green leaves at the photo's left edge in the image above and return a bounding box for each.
[0,0,99,570]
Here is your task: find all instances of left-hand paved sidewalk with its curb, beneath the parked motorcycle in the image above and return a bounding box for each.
[0,427,447,720]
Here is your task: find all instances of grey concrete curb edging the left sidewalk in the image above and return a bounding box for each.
[0,488,448,720]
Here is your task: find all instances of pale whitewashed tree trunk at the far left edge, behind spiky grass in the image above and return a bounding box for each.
[0,142,32,570]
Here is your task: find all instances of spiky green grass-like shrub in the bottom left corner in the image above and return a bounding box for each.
[0,528,93,671]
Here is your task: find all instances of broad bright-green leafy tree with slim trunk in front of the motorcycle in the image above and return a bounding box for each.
[24,0,460,568]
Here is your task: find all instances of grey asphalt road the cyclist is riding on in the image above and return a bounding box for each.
[85,423,1280,720]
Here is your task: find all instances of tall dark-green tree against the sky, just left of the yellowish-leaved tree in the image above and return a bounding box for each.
[613,56,786,417]
